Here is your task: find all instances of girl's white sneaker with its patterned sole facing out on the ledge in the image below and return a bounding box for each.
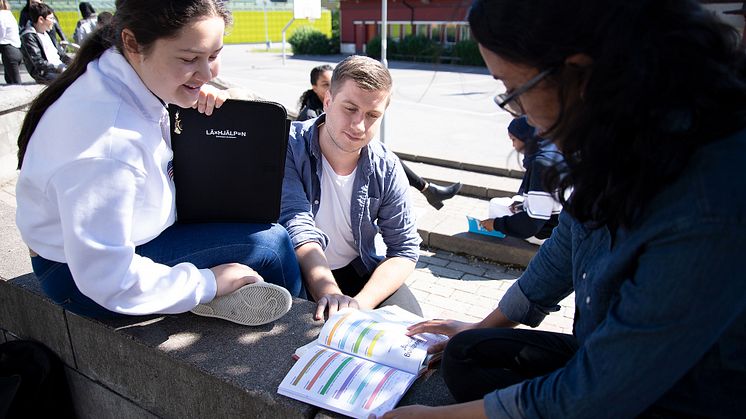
[191,282,293,326]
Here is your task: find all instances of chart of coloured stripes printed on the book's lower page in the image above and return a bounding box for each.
[290,349,413,410]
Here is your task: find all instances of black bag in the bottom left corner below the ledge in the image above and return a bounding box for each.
[0,340,75,419]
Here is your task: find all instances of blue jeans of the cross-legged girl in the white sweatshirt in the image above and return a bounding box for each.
[31,223,301,318]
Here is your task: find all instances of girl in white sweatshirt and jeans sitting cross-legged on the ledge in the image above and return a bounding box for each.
[16,0,300,325]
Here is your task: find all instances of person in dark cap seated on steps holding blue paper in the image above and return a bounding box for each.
[480,116,562,244]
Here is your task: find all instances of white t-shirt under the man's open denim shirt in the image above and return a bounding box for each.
[314,156,358,269]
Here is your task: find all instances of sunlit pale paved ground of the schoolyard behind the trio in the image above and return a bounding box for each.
[0,45,575,333]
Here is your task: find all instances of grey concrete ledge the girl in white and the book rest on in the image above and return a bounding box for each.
[0,274,453,418]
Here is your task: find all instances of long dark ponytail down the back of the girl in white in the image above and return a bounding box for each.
[18,24,116,169]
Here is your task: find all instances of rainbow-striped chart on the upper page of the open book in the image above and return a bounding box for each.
[324,313,404,357]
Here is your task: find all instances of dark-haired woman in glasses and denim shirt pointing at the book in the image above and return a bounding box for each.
[384,0,746,418]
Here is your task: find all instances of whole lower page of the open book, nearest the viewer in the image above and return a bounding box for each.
[278,345,417,418]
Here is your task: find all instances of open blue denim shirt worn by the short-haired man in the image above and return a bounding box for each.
[280,115,422,274]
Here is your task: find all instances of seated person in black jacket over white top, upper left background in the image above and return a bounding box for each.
[21,3,72,84]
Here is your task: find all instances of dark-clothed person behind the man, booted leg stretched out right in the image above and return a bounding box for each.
[298,64,462,209]
